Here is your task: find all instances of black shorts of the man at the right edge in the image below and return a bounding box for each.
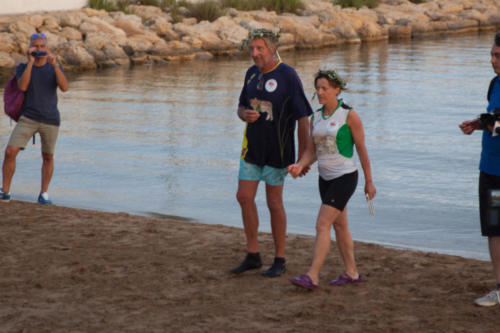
[479,171,500,236]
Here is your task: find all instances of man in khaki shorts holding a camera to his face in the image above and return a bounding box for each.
[0,33,68,205]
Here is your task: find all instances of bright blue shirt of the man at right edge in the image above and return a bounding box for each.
[479,78,500,176]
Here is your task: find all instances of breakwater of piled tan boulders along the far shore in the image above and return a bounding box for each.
[0,0,500,70]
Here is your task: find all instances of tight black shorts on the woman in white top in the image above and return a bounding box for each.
[319,170,358,211]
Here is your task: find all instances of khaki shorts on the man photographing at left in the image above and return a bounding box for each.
[8,116,59,155]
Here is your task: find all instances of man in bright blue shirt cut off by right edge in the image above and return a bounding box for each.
[460,33,500,306]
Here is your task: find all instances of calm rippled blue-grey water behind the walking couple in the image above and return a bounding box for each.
[0,33,493,259]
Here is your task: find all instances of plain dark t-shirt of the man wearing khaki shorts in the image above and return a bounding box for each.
[16,63,62,126]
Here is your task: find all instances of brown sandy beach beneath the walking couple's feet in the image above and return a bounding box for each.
[0,201,500,333]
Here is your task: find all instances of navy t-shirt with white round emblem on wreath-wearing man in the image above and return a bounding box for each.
[239,63,312,168]
